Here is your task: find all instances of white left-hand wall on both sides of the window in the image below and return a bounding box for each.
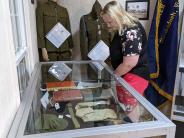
[0,0,38,138]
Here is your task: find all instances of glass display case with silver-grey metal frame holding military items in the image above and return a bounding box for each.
[8,61,175,138]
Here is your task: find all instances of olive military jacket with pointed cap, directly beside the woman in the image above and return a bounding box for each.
[80,1,110,60]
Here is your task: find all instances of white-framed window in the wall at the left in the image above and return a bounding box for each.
[9,0,29,97]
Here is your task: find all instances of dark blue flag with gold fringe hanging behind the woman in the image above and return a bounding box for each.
[145,0,179,106]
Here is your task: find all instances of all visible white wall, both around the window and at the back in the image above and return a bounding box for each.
[0,0,184,138]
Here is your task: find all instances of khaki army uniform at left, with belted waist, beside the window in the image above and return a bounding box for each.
[36,1,73,61]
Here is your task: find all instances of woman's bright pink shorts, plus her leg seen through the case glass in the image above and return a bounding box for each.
[116,73,148,122]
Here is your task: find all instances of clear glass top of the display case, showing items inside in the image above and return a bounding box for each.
[24,62,156,135]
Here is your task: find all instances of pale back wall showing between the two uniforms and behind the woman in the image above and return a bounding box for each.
[58,0,156,60]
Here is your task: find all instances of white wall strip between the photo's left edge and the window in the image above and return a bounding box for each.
[0,0,20,138]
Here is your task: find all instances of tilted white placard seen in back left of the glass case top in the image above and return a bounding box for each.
[49,63,72,81]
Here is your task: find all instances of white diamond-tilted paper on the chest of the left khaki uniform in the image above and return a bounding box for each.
[46,23,70,48]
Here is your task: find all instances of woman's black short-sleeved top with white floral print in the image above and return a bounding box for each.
[110,23,149,79]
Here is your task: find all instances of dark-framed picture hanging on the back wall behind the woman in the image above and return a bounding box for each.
[125,0,149,20]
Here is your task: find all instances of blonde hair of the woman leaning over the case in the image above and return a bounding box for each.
[102,1,138,33]
